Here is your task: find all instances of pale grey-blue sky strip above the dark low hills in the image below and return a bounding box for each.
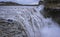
[0,0,39,4]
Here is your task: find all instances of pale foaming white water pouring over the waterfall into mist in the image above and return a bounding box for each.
[0,5,60,37]
